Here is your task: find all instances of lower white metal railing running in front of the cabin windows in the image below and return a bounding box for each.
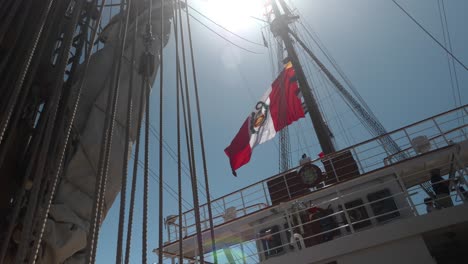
[166,162,467,263]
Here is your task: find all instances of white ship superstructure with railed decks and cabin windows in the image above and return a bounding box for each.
[155,105,468,264]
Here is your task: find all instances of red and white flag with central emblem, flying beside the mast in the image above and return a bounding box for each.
[224,63,304,176]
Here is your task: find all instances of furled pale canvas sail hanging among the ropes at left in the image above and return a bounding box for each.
[39,1,172,264]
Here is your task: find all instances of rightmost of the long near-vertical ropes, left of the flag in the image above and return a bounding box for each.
[186,0,218,264]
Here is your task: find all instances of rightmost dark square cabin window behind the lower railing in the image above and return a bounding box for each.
[367,189,400,223]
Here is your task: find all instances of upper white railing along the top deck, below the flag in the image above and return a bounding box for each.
[168,105,468,242]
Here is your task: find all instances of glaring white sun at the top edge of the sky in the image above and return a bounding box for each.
[202,0,266,31]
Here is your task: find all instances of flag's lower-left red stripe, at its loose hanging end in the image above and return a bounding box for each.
[224,118,252,171]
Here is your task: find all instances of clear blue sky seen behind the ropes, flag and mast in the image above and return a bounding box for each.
[97,0,468,263]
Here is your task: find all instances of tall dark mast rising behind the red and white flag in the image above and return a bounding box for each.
[271,0,335,154]
